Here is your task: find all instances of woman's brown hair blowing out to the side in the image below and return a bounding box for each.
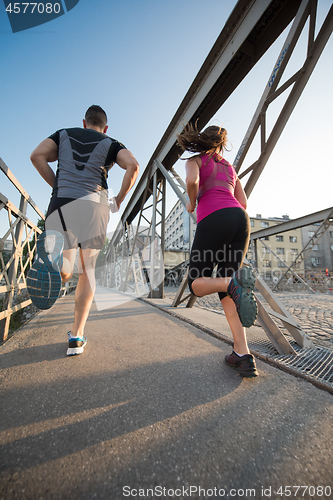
[177,123,227,156]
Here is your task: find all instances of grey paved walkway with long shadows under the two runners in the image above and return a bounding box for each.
[0,290,333,500]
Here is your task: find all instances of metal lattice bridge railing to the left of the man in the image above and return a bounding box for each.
[0,158,44,341]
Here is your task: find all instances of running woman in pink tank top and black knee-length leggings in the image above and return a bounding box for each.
[178,124,258,377]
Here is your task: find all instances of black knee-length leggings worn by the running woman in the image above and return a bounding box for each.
[188,207,251,300]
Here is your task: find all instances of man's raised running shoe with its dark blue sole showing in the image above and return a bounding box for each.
[27,231,64,309]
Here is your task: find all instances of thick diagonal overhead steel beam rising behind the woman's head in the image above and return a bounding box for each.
[121,0,301,229]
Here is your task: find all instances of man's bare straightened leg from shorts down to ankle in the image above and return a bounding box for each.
[71,248,100,337]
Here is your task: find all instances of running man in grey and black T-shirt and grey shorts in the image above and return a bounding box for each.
[27,105,139,355]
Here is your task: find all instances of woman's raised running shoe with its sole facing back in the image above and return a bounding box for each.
[227,267,258,328]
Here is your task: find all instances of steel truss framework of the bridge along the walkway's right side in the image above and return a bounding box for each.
[103,0,333,355]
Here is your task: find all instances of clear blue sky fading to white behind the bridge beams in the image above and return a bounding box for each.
[0,0,333,233]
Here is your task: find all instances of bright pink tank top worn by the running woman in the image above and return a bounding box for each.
[197,155,243,222]
